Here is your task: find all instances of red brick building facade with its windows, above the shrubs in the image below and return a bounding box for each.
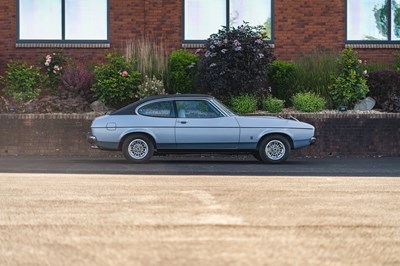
[0,0,400,73]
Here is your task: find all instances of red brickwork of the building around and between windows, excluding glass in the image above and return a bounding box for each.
[0,0,400,73]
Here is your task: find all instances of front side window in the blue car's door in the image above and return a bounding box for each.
[176,100,223,118]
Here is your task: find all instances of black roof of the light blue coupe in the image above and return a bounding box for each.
[110,94,214,115]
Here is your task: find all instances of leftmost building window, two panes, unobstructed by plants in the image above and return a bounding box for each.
[17,0,109,42]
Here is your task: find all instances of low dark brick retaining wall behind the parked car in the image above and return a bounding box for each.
[0,113,400,157]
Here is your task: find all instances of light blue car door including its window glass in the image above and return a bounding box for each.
[175,99,239,150]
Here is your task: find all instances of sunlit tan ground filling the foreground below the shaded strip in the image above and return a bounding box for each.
[0,174,400,265]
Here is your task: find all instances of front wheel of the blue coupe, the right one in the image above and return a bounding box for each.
[258,135,290,163]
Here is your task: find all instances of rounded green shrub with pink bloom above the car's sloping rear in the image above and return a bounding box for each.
[92,54,140,107]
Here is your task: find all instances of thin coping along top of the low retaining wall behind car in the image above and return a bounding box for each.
[0,112,400,120]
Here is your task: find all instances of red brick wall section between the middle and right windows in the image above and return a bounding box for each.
[274,0,345,59]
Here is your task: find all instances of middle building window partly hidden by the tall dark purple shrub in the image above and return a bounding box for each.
[183,0,273,42]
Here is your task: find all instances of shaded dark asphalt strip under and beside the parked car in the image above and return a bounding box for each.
[0,156,400,177]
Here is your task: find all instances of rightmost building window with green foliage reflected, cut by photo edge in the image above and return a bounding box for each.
[346,0,400,43]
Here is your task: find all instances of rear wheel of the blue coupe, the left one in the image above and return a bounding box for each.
[122,135,154,163]
